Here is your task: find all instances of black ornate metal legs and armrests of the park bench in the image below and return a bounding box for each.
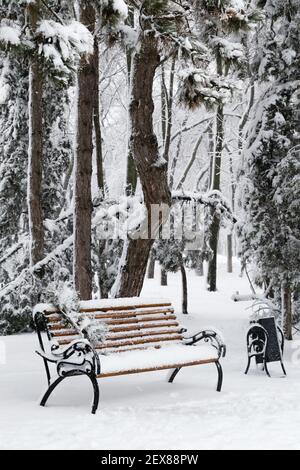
[34,312,226,414]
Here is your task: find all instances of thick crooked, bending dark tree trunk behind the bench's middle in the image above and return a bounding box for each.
[114,31,171,297]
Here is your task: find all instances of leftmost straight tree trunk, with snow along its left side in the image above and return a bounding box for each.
[27,2,44,266]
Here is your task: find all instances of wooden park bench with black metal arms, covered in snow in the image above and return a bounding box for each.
[34,297,226,413]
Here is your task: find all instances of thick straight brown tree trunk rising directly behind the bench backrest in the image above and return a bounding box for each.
[74,2,97,300]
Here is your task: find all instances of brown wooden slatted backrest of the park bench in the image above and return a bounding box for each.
[42,299,182,354]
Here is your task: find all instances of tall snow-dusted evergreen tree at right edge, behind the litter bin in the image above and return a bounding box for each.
[240,0,300,339]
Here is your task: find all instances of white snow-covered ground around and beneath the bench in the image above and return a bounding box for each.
[0,259,300,449]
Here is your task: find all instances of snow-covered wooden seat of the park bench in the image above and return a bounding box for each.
[98,343,218,377]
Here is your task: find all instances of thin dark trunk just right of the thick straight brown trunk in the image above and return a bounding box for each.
[93,37,104,194]
